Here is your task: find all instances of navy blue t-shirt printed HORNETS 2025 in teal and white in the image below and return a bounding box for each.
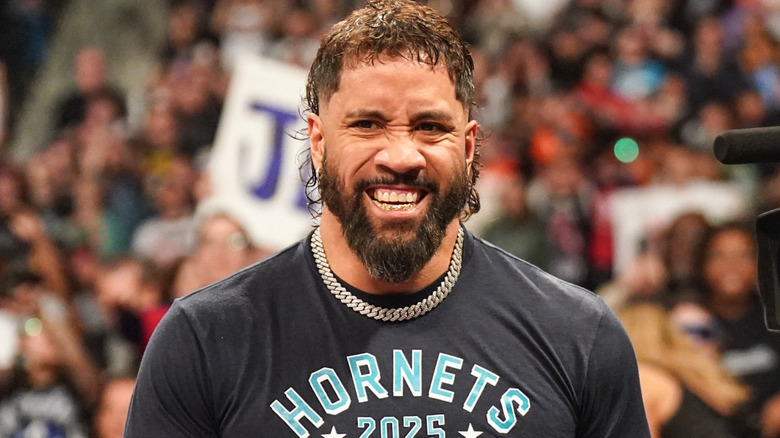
[126,233,649,438]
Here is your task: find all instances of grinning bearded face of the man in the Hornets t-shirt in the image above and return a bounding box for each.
[309,57,477,282]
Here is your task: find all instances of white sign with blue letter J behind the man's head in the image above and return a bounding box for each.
[205,56,312,250]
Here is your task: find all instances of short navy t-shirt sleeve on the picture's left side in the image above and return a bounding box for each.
[124,302,218,438]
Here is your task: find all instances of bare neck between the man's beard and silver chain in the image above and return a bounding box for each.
[320,208,460,295]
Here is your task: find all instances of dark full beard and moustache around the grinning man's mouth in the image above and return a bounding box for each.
[319,159,471,283]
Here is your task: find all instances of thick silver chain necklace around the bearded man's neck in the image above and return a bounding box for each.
[311,227,465,321]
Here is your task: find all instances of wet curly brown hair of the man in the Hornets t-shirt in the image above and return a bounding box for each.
[303,0,481,219]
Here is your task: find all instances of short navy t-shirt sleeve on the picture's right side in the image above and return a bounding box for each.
[577,306,650,438]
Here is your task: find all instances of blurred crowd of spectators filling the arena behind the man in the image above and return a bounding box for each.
[0,0,780,438]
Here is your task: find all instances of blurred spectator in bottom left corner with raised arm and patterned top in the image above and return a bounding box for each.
[0,274,100,437]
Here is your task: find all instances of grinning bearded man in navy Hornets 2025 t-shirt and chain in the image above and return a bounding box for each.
[126,0,649,438]
